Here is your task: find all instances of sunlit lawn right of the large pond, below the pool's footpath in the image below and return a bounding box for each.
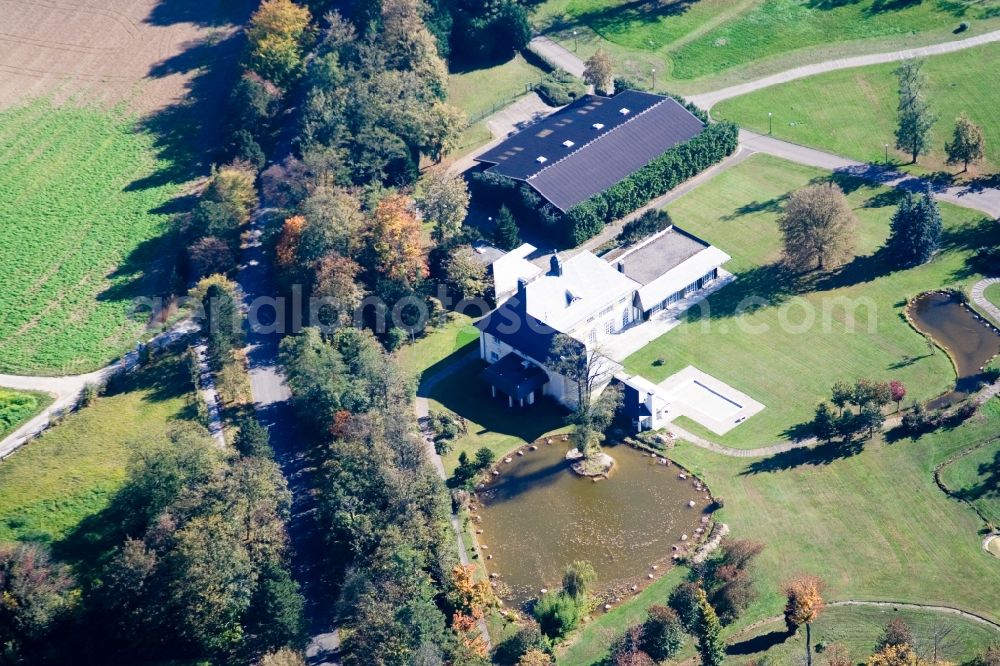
[671,399,1000,626]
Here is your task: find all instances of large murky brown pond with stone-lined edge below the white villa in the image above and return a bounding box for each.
[474,438,712,606]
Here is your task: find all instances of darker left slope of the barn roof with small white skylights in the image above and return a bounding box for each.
[476,90,664,180]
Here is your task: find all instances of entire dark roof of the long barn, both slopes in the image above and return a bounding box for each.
[476,90,705,212]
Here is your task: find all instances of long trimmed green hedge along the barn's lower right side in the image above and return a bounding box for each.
[566,122,739,245]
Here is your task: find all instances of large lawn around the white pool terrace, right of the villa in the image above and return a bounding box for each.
[625,155,1000,448]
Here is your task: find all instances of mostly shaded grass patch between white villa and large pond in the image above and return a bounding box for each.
[429,360,568,472]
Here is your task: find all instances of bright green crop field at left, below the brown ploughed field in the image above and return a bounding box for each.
[0,100,177,374]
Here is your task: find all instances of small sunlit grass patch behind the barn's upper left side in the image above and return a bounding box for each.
[448,55,545,122]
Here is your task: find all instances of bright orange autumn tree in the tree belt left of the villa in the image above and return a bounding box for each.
[368,194,427,286]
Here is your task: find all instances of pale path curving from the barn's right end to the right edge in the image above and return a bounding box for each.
[692,30,1000,110]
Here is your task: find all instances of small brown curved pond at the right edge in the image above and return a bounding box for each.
[908,291,1000,408]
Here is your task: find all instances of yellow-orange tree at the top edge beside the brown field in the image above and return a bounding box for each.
[247,0,310,88]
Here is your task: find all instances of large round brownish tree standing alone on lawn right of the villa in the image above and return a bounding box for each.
[778,183,858,271]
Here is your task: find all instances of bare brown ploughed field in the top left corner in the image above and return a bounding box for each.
[0,0,255,114]
